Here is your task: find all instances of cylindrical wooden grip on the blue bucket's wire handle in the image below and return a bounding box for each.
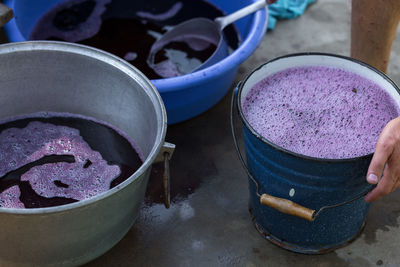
[260,194,315,222]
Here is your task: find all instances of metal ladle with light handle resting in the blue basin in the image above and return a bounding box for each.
[147,0,269,77]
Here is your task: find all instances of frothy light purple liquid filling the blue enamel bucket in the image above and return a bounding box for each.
[243,67,400,159]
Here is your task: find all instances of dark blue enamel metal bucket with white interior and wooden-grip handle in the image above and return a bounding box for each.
[231,53,400,254]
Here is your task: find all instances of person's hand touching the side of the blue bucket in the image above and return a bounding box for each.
[365,117,400,202]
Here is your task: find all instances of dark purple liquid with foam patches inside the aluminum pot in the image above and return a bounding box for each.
[0,113,143,208]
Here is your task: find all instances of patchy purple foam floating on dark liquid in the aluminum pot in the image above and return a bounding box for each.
[0,121,121,208]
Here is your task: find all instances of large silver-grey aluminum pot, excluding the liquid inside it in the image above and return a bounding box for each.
[0,42,167,266]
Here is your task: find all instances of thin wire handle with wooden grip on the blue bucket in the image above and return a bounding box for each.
[230,85,375,222]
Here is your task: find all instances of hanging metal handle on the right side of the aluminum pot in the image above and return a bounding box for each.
[154,142,175,209]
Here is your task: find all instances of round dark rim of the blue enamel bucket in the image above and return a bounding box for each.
[236,52,400,164]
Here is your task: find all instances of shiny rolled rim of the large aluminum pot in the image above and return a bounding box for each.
[0,41,167,216]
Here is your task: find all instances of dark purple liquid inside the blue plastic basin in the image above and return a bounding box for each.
[29,0,239,79]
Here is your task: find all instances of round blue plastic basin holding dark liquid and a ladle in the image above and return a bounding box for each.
[4,0,268,124]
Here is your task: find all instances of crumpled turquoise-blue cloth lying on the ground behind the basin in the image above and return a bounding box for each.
[268,0,316,30]
